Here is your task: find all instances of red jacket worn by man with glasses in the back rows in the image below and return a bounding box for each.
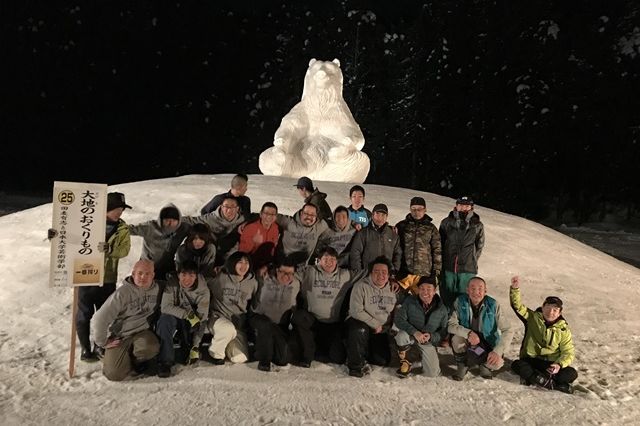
[238,220,280,270]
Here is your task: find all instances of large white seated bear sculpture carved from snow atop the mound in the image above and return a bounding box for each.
[258,59,369,183]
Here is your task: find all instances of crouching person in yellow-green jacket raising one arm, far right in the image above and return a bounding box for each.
[509,276,578,393]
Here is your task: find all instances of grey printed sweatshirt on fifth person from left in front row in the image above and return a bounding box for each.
[300,265,353,323]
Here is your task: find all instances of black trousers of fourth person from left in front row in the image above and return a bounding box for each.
[249,314,289,365]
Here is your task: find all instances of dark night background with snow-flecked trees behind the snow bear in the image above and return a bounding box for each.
[0,0,640,223]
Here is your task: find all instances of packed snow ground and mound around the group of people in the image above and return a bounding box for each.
[0,175,640,425]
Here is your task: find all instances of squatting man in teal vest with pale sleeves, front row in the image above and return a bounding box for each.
[448,277,513,381]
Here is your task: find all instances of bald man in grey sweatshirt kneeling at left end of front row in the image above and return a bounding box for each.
[92,260,160,381]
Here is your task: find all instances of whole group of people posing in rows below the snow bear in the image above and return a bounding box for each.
[52,175,577,393]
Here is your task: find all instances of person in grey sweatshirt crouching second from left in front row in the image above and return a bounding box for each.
[156,260,210,377]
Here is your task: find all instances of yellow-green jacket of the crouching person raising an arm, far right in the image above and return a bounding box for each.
[509,288,575,368]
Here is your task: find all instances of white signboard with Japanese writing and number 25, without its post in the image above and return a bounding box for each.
[49,182,107,287]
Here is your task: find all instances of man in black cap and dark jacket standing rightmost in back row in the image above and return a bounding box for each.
[440,197,484,311]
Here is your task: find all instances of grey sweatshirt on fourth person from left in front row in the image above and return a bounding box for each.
[252,274,300,324]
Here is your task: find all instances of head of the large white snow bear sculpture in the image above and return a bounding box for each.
[302,59,342,102]
